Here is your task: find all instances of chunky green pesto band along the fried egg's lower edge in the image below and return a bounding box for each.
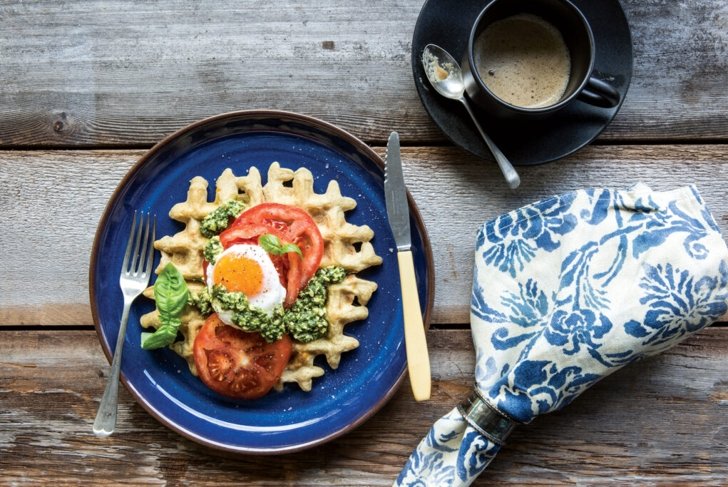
[191,266,346,343]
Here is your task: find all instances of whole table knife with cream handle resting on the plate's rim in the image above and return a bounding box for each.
[384,132,431,401]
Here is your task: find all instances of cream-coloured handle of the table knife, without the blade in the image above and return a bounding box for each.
[397,250,431,401]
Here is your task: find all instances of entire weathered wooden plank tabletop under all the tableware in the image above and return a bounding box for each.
[0,0,728,486]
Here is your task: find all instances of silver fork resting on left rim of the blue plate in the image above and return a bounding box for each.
[93,211,157,437]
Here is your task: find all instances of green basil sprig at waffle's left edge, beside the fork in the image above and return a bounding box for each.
[142,262,190,350]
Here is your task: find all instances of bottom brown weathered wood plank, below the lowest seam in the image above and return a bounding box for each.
[0,328,728,486]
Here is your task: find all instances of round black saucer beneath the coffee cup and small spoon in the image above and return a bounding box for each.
[412,0,632,165]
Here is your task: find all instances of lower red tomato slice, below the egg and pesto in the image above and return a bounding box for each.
[192,314,293,399]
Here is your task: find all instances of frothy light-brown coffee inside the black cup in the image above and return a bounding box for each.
[474,14,571,108]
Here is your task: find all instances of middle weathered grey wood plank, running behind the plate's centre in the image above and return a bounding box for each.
[0,145,728,326]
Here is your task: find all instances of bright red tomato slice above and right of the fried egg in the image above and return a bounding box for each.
[220,203,324,304]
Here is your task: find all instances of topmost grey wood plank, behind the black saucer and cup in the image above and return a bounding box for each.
[0,0,728,147]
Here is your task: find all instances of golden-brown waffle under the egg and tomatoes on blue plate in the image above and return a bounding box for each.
[141,162,382,391]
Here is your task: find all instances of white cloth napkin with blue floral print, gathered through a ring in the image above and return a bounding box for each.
[395,184,728,487]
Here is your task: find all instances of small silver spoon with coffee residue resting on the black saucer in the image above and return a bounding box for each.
[422,44,521,189]
